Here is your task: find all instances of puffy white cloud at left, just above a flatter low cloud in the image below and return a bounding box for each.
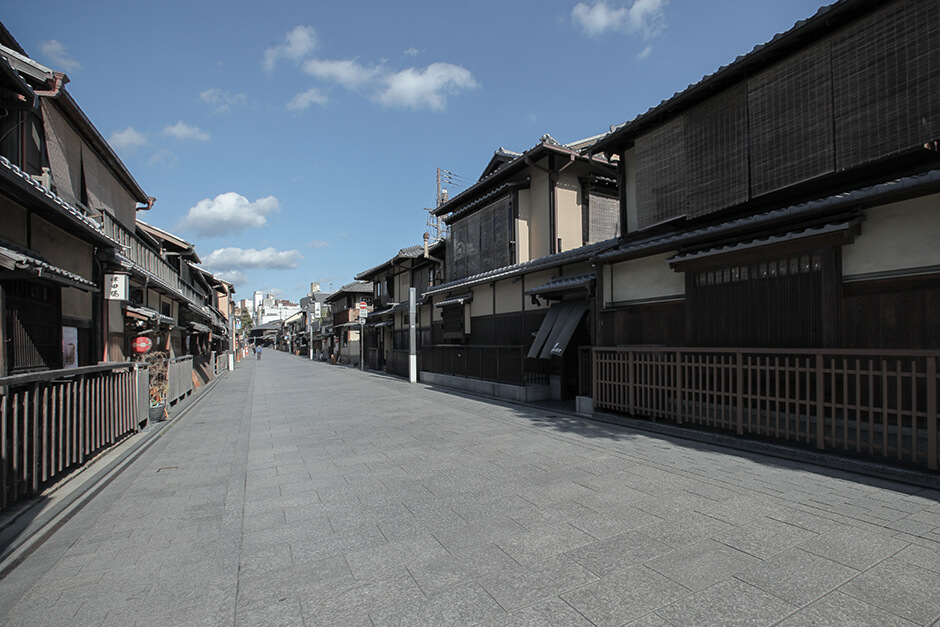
[177,192,281,237]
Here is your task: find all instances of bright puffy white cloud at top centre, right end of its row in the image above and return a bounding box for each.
[376,63,480,111]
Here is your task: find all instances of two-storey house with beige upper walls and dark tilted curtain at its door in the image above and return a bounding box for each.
[421,135,620,399]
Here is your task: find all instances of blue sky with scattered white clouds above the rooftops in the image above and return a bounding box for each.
[7,0,820,301]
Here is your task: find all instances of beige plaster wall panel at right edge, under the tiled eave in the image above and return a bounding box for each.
[842,194,940,277]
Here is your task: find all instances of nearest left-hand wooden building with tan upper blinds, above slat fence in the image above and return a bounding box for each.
[0,27,153,376]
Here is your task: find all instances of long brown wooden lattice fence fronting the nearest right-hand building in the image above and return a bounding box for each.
[590,347,940,470]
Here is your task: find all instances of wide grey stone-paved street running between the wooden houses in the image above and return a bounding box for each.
[0,351,940,627]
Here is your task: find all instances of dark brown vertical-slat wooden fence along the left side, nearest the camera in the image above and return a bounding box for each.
[0,362,148,510]
